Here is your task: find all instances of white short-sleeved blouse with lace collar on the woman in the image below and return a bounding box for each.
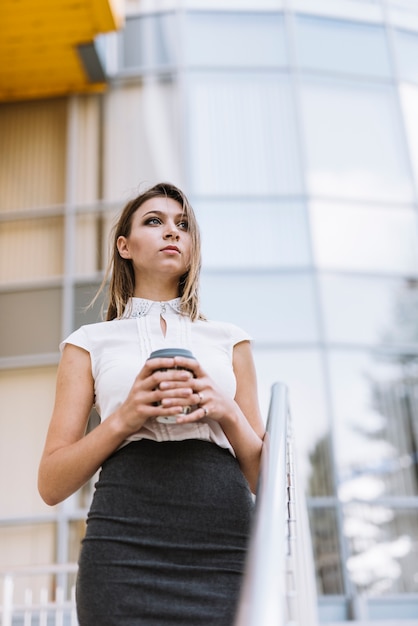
[60,298,250,454]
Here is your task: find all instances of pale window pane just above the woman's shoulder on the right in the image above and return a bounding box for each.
[202,272,318,345]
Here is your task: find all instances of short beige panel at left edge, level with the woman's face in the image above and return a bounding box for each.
[0,217,64,284]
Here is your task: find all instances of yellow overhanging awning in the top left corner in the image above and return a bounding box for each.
[0,0,123,101]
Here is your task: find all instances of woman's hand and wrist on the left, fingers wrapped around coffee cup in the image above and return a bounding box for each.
[113,358,198,437]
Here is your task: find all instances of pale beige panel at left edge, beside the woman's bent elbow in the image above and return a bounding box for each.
[0,367,56,517]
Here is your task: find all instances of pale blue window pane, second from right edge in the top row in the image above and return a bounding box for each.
[295,16,391,78]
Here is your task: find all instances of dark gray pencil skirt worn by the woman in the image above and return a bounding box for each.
[77,440,253,626]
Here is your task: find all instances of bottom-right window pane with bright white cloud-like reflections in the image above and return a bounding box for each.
[344,502,418,596]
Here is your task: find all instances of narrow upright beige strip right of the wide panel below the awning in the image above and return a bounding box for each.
[76,95,100,204]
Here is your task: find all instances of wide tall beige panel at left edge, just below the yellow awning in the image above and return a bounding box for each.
[0,99,67,211]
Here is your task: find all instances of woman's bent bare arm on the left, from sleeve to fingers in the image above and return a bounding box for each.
[38,344,201,505]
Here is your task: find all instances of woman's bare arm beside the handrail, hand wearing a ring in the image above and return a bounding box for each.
[173,341,265,493]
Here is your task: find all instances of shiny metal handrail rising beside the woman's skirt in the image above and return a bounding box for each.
[235,383,317,626]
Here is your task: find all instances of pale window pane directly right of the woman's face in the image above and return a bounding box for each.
[193,199,310,268]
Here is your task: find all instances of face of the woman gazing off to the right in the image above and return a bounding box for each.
[117,197,192,280]
